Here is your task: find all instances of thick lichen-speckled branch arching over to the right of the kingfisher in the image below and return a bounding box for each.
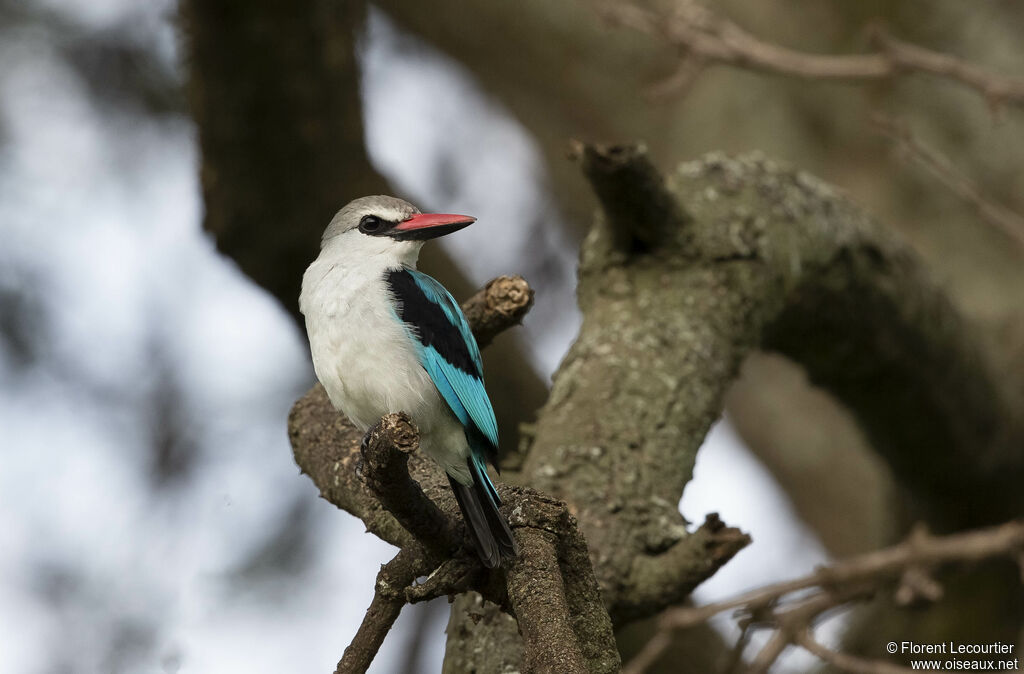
[521,141,1024,621]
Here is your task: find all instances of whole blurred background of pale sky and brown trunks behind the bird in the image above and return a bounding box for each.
[0,0,1024,674]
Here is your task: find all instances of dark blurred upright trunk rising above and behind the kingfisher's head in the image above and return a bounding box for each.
[179,0,386,319]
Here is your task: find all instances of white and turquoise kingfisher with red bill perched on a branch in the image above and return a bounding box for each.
[299,196,516,568]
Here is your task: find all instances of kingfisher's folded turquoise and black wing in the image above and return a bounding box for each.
[384,267,498,450]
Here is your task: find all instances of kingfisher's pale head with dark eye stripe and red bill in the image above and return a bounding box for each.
[321,195,476,266]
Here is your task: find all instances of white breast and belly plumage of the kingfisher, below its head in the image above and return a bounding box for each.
[299,229,473,485]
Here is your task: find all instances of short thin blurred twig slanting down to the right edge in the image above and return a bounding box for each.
[871,115,1024,247]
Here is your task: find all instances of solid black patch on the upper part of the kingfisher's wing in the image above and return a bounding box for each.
[384,268,482,378]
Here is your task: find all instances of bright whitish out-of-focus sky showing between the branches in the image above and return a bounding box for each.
[0,0,825,674]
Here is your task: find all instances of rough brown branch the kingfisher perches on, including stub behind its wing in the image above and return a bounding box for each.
[290,279,620,673]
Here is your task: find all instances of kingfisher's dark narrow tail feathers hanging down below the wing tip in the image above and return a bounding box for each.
[449,457,518,568]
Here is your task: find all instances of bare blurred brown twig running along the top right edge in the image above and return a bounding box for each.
[601,0,1024,107]
